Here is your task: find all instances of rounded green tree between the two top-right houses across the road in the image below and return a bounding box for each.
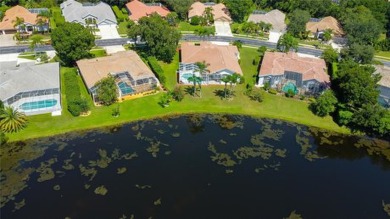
[287,9,310,38]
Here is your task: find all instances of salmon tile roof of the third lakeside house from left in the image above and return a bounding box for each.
[181,42,242,75]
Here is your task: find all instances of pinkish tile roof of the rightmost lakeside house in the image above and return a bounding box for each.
[259,52,330,83]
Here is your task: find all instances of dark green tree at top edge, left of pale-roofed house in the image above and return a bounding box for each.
[225,0,253,23]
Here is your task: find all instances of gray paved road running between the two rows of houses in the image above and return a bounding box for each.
[0,35,390,66]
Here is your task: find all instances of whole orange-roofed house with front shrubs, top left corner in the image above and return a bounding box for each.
[0,5,49,34]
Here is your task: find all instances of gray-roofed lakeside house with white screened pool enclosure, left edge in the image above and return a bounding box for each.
[0,62,61,116]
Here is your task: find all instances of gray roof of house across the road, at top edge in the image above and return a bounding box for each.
[60,0,117,25]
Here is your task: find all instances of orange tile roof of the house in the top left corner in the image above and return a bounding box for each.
[0,5,38,30]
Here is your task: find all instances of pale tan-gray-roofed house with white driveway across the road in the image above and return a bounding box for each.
[248,9,287,43]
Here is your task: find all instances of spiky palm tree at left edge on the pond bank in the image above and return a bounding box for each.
[0,106,27,133]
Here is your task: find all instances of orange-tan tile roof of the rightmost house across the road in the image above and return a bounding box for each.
[306,16,344,36]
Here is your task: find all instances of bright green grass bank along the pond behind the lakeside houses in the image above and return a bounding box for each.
[8,48,349,141]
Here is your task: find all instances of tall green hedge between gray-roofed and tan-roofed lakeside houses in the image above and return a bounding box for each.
[64,69,89,116]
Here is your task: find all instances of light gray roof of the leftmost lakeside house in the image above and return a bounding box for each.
[0,62,60,100]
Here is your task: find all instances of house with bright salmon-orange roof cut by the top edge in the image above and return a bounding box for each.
[126,0,170,22]
